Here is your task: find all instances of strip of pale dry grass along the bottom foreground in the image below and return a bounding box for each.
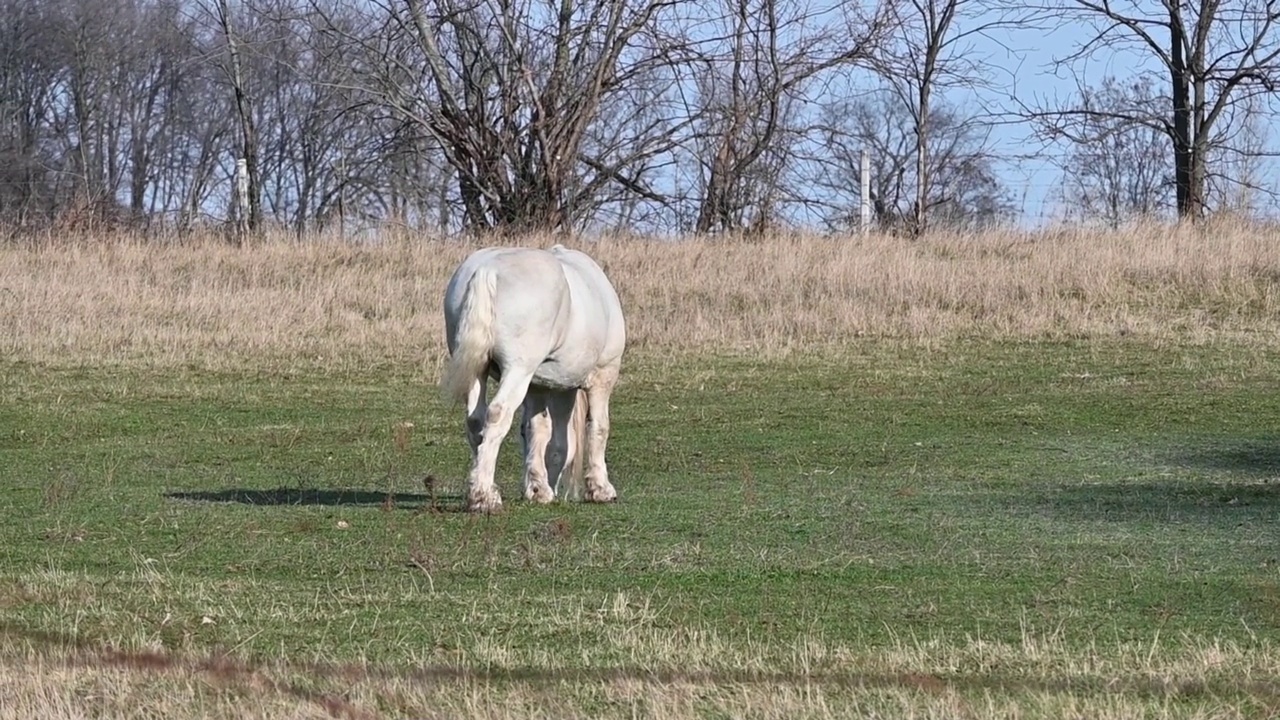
[0,630,1280,720]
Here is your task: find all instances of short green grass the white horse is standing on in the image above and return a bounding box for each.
[0,342,1280,716]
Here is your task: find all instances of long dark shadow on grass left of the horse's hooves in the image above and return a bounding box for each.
[165,487,462,512]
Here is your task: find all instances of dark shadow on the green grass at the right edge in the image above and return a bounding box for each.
[1036,438,1280,527]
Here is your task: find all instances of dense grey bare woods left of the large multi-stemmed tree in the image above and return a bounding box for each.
[0,0,419,232]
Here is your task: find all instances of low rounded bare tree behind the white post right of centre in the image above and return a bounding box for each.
[810,92,1012,229]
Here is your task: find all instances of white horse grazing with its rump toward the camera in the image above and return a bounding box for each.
[440,245,626,512]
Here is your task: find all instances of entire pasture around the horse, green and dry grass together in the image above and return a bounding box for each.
[0,222,1280,719]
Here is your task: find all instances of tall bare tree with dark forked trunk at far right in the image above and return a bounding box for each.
[1025,0,1280,218]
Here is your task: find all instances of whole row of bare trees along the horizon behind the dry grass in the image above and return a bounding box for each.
[0,0,1272,236]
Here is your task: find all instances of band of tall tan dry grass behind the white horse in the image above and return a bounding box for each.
[0,223,1280,368]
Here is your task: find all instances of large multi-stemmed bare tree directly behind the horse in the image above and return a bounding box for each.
[327,0,673,231]
